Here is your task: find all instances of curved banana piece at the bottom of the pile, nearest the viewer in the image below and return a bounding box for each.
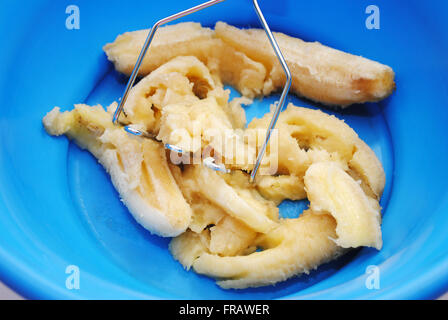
[190,212,342,289]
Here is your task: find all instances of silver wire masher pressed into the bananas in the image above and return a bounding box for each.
[112,0,291,182]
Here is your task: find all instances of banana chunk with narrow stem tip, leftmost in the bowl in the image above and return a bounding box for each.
[43,105,192,237]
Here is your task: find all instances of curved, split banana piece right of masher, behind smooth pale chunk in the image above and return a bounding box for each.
[248,104,385,201]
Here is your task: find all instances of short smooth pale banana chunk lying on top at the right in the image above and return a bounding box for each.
[304,162,382,250]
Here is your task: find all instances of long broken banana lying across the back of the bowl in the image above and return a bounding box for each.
[103,22,395,107]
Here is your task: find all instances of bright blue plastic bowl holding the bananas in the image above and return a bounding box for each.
[0,0,448,299]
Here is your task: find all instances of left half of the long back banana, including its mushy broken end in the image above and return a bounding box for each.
[103,22,266,98]
